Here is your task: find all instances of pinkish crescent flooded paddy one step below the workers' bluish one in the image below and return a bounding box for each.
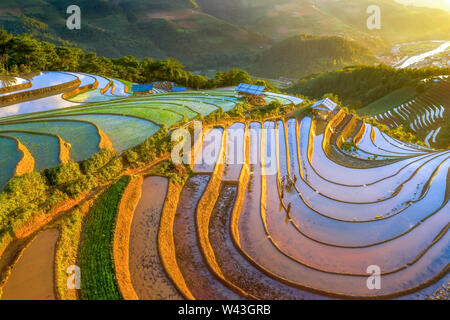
[266,123,447,275]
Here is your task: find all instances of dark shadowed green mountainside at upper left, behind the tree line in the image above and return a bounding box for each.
[0,0,270,69]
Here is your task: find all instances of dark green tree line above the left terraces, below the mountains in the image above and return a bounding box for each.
[0,29,274,89]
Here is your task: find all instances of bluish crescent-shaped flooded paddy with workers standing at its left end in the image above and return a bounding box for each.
[279,120,448,246]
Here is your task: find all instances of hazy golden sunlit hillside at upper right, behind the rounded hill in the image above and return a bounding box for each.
[197,0,450,50]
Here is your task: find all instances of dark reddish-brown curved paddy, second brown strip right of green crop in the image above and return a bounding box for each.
[173,175,240,300]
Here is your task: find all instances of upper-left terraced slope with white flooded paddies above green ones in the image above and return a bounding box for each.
[0,72,301,188]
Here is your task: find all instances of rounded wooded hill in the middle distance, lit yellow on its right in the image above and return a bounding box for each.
[249,35,376,78]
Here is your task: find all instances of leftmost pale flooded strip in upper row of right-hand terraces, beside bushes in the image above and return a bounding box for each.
[194,128,223,173]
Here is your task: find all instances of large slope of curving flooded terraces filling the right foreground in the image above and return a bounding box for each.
[127,113,450,299]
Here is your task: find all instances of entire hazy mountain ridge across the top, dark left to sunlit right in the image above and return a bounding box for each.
[0,0,450,70]
